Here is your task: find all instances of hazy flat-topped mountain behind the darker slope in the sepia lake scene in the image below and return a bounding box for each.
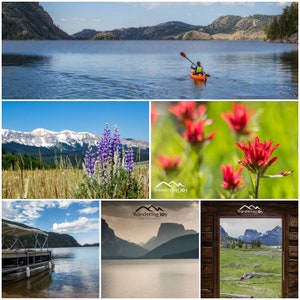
[143,223,197,250]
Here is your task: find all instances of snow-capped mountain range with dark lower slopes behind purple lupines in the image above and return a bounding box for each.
[2,128,149,163]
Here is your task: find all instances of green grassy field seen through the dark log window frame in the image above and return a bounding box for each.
[220,247,282,298]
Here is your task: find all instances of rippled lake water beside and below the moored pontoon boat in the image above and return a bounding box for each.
[2,247,99,298]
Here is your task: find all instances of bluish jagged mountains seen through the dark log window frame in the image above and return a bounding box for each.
[220,226,282,246]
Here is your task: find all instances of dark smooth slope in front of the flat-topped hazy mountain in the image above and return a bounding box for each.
[144,234,199,259]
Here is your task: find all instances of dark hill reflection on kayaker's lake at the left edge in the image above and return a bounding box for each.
[2,54,51,66]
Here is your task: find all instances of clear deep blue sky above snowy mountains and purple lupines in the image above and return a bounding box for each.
[2,101,149,141]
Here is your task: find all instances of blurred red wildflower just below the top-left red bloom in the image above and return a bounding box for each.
[184,120,216,144]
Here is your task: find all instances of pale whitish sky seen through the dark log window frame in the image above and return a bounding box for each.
[220,218,282,237]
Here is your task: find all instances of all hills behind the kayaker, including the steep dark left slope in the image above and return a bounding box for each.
[2,2,274,40]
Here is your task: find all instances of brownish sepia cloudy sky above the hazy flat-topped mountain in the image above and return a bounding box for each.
[101,200,199,244]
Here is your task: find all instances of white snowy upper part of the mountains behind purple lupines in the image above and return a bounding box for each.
[2,128,149,149]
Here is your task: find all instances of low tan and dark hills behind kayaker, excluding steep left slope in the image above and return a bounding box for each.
[72,15,274,40]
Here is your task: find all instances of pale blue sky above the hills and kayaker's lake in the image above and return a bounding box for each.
[41,1,290,34]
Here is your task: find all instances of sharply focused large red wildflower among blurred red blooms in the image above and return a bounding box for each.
[236,137,279,176]
